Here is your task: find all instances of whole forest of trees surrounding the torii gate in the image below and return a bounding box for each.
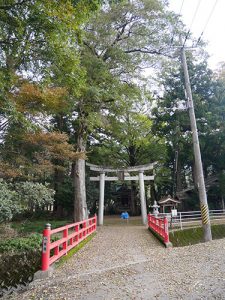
[0,0,225,222]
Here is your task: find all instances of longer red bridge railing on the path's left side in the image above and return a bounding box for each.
[41,216,97,271]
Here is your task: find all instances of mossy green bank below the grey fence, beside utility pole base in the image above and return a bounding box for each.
[170,224,225,247]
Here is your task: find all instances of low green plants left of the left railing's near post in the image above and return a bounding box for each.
[0,234,42,253]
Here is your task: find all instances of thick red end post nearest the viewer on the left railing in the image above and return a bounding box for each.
[41,224,51,271]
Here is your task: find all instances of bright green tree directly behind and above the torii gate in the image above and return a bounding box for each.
[87,84,166,215]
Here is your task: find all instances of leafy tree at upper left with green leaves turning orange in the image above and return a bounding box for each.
[0,0,99,218]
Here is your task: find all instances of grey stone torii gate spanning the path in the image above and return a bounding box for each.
[86,162,156,225]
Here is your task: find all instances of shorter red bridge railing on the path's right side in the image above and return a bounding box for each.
[148,214,170,245]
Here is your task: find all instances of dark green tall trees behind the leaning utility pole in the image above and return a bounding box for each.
[153,53,225,202]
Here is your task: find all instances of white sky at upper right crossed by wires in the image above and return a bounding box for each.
[169,0,225,69]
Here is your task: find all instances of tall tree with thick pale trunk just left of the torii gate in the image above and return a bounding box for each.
[71,0,179,218]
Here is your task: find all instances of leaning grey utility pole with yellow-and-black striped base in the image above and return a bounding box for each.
[180,37,212,242]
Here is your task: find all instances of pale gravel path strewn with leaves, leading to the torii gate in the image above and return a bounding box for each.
[7,226,225,300]
